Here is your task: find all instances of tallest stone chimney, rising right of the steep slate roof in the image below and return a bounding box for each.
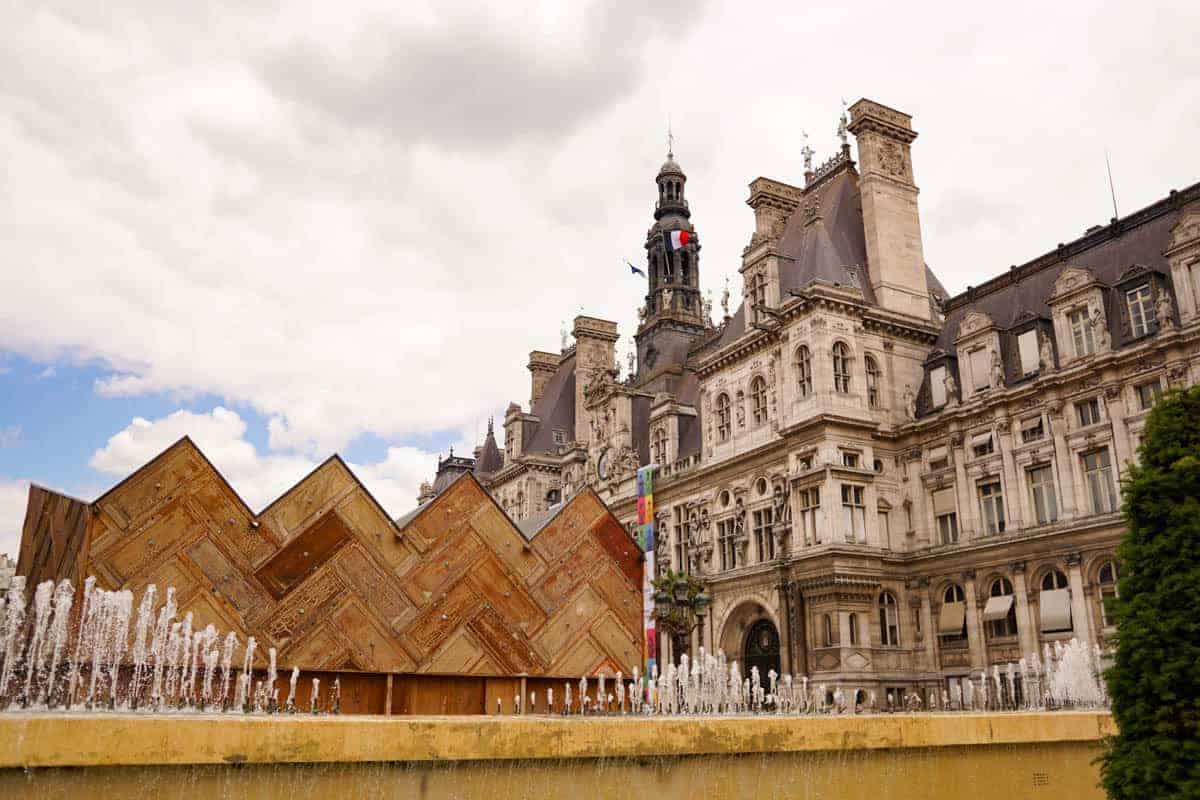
[850,100,930,319]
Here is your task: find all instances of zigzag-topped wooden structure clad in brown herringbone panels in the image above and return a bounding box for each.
[18,438,642,675]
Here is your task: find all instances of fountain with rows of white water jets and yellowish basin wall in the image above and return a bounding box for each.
[0,577,1112,800]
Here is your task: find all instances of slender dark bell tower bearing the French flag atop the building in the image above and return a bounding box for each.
[636,149,708,388]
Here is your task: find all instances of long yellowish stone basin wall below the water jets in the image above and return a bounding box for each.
[0,711,1115,800]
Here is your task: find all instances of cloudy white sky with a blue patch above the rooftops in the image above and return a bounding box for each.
[0,0,1200,552]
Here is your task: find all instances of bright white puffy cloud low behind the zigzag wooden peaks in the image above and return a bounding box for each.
[89,407,437,518]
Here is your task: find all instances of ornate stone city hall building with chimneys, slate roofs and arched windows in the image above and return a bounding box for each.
[421,100,1200,703]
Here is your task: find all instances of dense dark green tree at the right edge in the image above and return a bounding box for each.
[1100,386,1200,800]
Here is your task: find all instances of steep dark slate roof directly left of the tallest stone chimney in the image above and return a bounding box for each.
[779,162,875,302]
